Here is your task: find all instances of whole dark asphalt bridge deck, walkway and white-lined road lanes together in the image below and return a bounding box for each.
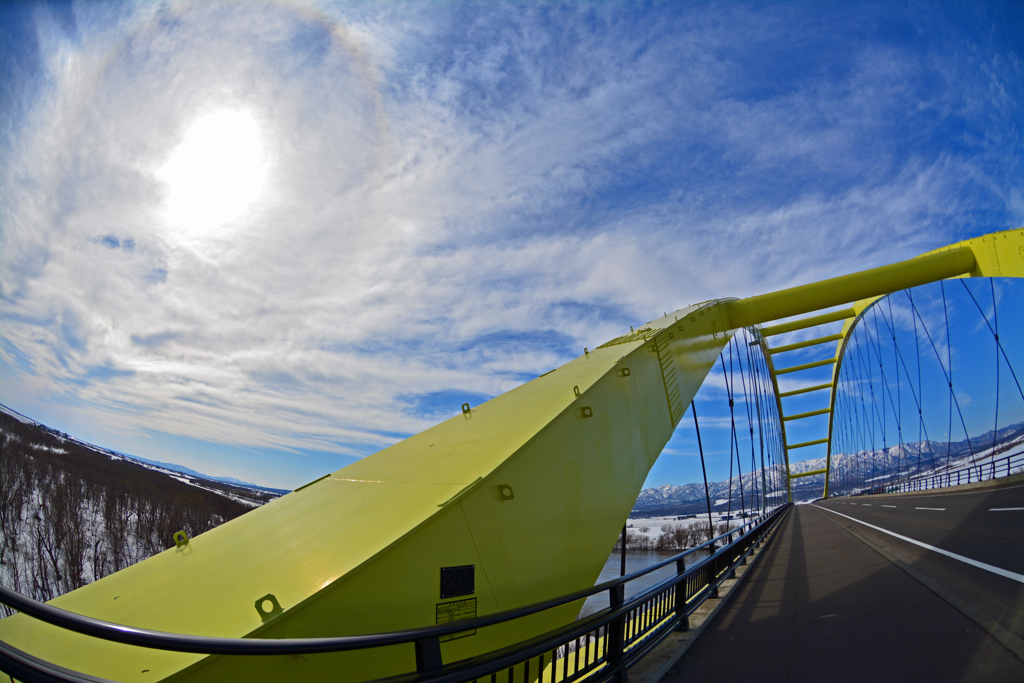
[662,485,1024,683]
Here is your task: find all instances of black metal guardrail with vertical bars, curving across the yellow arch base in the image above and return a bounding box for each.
[0,504,791,683]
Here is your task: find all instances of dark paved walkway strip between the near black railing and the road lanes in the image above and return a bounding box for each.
[662,506,1024,683]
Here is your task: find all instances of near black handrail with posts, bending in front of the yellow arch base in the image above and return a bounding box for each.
[0,504,790,683]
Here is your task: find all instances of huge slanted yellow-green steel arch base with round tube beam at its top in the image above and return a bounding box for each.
[0,228,1024,683]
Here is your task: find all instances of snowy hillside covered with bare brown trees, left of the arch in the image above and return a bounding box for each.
[0,405,287,616]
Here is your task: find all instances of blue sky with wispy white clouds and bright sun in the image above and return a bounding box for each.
[0,1,1024,488]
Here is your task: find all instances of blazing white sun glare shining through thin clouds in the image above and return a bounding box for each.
[158,110,267,236]
